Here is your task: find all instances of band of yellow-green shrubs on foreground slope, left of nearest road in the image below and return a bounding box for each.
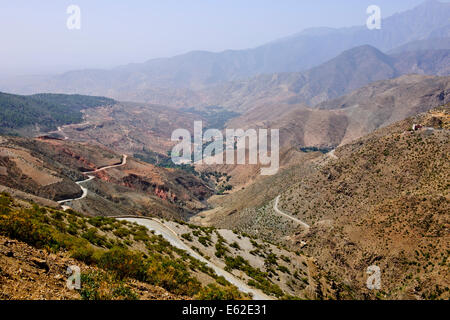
[0,193,247,300]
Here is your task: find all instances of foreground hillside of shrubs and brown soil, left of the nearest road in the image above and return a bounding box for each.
[0,193,241,300]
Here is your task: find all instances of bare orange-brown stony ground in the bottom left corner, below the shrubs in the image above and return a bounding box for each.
[0,236,187,300]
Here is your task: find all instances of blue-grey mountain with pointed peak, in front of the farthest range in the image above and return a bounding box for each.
[176,46,450,113]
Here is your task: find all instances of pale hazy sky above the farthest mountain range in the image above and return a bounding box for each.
[0,0,442,76]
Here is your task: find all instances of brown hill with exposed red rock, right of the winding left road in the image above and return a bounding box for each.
[68,158,213,220]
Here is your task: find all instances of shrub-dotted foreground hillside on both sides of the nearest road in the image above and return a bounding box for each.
[0,193,334,300]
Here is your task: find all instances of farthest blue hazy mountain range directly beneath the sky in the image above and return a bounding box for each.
[0,0,450,106]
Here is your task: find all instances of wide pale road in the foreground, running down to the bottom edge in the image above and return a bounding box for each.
[118,218,273,300]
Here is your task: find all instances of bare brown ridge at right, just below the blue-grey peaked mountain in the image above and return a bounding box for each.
[227,75,450,148]
